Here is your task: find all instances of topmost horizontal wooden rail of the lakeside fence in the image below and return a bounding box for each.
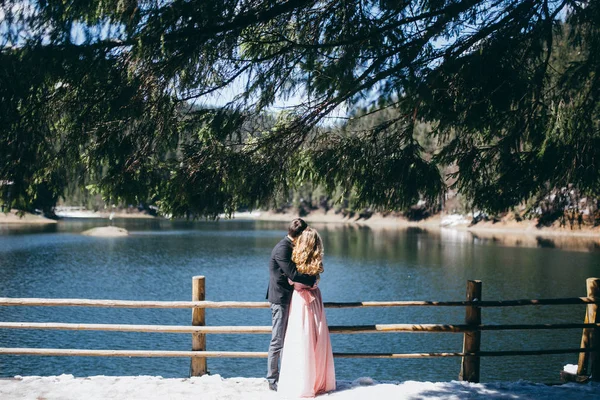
[0,297,600,309]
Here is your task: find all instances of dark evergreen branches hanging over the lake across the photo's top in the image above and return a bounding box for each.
[0,0,600,216]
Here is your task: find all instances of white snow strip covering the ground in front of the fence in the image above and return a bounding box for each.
[0,375,600,400]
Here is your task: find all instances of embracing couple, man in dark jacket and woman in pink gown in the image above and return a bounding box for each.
[267,218,335,397]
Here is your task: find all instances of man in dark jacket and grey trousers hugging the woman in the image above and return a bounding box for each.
[267,218,316,390]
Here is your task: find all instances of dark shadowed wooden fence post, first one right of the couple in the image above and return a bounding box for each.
[458,281,481,383]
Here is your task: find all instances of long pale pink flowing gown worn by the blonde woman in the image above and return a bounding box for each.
[277,283,335,398]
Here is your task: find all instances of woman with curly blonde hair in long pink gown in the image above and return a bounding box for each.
[277,228,335,398]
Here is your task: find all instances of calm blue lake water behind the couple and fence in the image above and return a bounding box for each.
[0,220,600,382]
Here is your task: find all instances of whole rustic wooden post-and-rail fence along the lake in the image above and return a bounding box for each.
[0,276,600,382]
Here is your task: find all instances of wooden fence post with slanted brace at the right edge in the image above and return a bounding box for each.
[577,278,600,382]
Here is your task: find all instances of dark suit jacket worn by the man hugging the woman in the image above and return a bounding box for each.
[267,236,316,304]
